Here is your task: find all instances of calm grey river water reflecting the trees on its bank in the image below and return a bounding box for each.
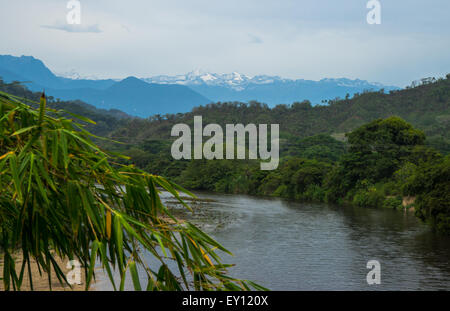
[97,193,450,290]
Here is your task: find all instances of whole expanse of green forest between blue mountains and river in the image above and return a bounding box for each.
[0,75,450,234]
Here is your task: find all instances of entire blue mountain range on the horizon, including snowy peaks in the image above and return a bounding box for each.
[0,55,398,117]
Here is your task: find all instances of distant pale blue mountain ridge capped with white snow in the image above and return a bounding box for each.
[142,70,398,106]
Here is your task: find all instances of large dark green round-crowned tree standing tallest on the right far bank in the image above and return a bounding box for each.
[327,117,431,201]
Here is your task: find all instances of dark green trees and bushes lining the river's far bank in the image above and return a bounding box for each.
[161,117,450,234]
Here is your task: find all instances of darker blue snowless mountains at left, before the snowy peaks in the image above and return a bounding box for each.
[0,55,210,117]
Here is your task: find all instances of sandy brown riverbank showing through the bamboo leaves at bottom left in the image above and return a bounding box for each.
[0,253,94,291]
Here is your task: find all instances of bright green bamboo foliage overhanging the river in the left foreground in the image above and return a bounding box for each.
[0,92,262,290]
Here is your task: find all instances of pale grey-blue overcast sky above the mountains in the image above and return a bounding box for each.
[0,0,450,86]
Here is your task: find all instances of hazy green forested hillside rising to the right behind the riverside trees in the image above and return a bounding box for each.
[112,75,450,153]
